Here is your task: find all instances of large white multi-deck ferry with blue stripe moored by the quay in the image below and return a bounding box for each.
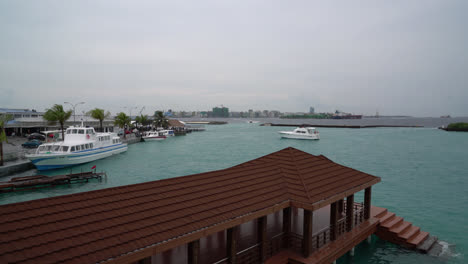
[26,126,127,170]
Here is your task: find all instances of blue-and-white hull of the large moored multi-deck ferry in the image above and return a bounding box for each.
[26,144,128,170]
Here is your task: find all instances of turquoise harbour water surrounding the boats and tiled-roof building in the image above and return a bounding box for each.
[0,123,468,263]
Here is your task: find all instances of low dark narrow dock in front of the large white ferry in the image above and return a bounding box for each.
[0,171,107,193]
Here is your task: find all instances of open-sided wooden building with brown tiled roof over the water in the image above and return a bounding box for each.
[0,148,380,264]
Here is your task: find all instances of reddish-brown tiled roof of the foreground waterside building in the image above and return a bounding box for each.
[0,148,380,263]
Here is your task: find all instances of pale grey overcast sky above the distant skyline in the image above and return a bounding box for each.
[0,0,468,116]
